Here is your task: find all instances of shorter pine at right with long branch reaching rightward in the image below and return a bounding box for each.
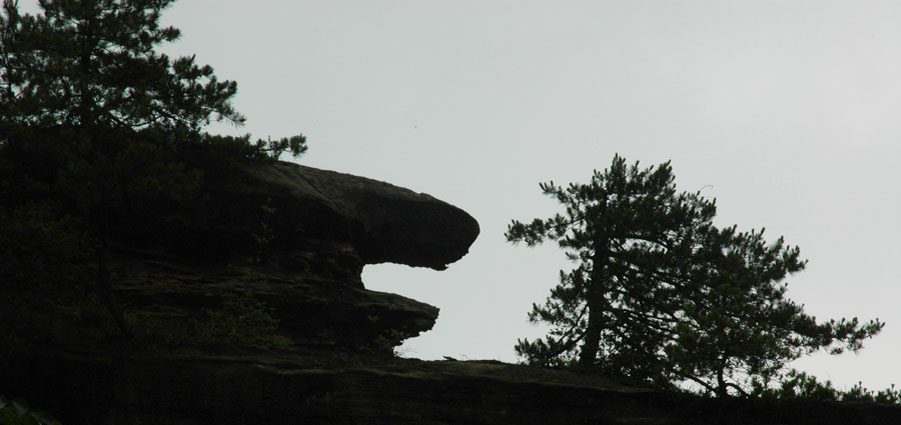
[661,226,884,397]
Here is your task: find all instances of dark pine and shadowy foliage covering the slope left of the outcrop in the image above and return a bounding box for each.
[0,0,307,339]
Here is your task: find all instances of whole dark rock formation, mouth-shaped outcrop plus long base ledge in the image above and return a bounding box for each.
[0,162,901,425]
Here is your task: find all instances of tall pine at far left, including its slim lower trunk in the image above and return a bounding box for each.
[0,0,306,334]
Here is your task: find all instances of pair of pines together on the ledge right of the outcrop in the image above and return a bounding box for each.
[506,155,883,396]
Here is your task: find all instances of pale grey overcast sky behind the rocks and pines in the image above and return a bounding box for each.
[15,0,901,389]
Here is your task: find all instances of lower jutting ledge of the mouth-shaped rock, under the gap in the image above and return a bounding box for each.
[111,251,438,348]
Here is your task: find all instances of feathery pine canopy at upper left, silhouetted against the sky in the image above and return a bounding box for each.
[0,0,245,136]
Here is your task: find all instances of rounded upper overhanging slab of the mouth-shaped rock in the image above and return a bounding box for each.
[237,162,479,270]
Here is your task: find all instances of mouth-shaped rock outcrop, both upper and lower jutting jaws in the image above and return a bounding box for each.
[110,162,479,347]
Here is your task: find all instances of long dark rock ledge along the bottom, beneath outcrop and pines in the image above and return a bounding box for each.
[2,353,901,425]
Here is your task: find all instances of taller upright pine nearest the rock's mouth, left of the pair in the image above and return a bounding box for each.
[506,155,716,374]
